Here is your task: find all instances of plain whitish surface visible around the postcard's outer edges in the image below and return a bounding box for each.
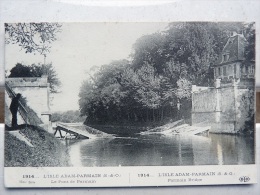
[0,0,260,194]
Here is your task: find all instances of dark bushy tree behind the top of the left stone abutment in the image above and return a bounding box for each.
[8,63,61,93]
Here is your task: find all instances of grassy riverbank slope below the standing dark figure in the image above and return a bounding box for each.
[4,126,70,167]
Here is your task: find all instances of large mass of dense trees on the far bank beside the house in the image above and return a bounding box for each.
[79,22,252,124]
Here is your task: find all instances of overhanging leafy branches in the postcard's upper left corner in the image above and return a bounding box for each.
[5,22,61,55]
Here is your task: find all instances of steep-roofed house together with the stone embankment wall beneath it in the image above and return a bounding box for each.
[192,33,255,134]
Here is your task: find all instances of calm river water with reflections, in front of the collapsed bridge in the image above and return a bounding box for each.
[68,134,254,167]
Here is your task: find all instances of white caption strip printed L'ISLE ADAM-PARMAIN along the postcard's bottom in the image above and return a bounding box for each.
[4,165,257,188]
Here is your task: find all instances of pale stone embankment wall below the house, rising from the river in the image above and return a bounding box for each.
[192,79,252,134]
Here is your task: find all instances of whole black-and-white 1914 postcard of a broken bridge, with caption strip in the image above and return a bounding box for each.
[4,21,257,187]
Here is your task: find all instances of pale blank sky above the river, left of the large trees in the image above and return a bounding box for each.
[5,22,168,112]
